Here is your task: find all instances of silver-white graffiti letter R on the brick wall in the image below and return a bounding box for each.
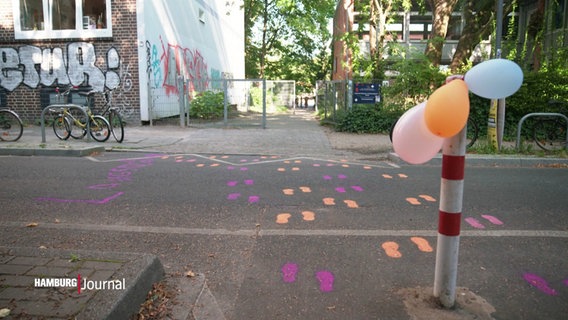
[67,42,105,92]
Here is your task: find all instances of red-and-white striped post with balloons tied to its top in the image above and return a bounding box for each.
[434,117,467,308]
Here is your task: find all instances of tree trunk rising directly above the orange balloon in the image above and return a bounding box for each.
[424,0,458,66]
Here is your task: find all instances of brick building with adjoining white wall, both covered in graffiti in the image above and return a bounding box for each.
[0,0,244,123]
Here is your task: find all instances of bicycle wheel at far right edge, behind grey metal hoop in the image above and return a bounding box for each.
[533,118,566,151]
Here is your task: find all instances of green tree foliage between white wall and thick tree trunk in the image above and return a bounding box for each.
[245,0,335,92]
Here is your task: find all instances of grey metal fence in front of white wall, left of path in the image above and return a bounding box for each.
[149,78,295,128]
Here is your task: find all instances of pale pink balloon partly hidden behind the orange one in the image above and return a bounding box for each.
[392,102,444,164]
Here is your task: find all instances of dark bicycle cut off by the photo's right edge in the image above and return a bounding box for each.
[533,100,568,151]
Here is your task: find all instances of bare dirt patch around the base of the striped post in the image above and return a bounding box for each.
[397,287,495,320]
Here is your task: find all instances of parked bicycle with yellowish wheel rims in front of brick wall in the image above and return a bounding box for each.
[52,87,111,142]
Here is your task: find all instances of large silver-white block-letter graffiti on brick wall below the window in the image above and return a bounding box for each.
[0,42,120,91]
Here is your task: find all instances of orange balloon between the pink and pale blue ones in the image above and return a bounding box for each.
[424,80,469,138]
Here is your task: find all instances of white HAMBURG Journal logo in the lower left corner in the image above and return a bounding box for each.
[34,274,126,293]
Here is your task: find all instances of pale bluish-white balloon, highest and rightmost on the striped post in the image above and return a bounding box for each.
[464,59,523,99]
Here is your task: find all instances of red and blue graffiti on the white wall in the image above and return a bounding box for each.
[146,37,209,94]
